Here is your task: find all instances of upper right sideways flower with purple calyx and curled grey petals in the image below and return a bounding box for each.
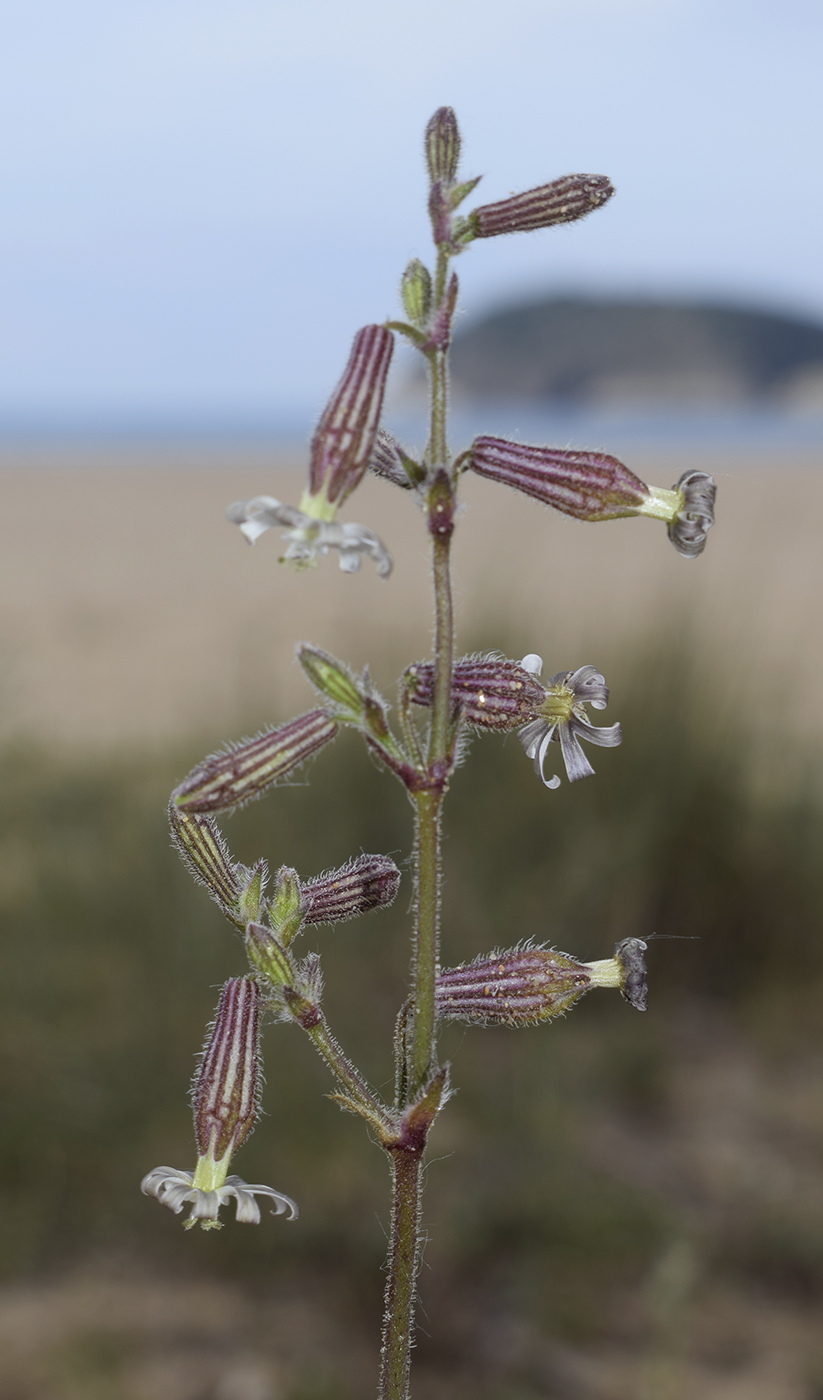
[466,437,717,559]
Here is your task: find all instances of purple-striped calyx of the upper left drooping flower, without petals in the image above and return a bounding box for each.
[300,326,395,521]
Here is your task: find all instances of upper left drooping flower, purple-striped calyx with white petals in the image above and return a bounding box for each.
[225,326,395,578]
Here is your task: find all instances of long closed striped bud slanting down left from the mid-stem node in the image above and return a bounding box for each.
[172,710,337,813]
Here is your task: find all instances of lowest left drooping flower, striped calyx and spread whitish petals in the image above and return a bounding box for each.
[141,977,297,1229]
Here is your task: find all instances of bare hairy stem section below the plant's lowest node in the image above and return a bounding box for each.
[378,1151,423,1400]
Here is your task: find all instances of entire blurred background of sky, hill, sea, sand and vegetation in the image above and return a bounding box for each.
[0,0,823,1400]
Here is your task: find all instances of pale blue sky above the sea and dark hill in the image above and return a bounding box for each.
[0,0,823,424]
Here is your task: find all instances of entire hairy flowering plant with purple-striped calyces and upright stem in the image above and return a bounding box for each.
[143,106,715,1400]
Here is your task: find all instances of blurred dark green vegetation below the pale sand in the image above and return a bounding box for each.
[0,641,823,1397]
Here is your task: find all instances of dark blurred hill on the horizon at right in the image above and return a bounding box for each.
[453,298,823,403]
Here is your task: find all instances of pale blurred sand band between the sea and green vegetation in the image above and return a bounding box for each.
[0,448,823,749]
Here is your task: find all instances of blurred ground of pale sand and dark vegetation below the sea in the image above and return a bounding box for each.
[0,448,823,1400]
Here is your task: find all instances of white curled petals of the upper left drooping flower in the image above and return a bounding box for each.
[225,496,392,578]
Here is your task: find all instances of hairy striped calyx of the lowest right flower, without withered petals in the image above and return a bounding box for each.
[435,948,595,1026]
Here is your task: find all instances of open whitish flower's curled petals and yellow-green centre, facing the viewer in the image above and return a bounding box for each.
[518,652,623,788]
